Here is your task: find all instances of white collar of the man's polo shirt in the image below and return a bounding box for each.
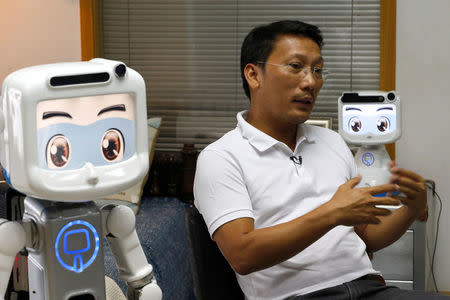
[236,110,314,152]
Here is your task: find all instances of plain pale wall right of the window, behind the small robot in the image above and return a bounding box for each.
[396,0,450,291]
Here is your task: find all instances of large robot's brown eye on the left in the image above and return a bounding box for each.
[46,135,70,169]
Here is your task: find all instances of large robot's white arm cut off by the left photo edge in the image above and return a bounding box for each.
[0,219,26,299]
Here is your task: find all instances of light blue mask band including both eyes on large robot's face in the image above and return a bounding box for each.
[37,118,136,170]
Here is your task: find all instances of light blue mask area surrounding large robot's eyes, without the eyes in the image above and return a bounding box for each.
[37,118,136,171]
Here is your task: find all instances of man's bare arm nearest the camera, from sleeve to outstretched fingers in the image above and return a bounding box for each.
[213,177,399,275]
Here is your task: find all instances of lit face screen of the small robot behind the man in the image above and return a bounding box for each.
[342,104,397,135]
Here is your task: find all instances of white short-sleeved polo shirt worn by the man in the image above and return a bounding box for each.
[194,112,378,299]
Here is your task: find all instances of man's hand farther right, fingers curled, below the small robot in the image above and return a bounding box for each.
[389,161,427,219]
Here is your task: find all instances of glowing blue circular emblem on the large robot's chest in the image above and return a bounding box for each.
[55,220,100,273]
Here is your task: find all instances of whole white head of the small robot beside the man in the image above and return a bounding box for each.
[338,91,401,145]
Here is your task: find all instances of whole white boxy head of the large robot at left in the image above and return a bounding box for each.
[0,59,148,201]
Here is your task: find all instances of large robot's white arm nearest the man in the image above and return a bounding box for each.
[106,205,162,300]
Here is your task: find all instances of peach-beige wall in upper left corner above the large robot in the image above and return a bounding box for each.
[0,0,81,82]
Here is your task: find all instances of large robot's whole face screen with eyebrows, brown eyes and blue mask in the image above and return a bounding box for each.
[36,94,136,170]
